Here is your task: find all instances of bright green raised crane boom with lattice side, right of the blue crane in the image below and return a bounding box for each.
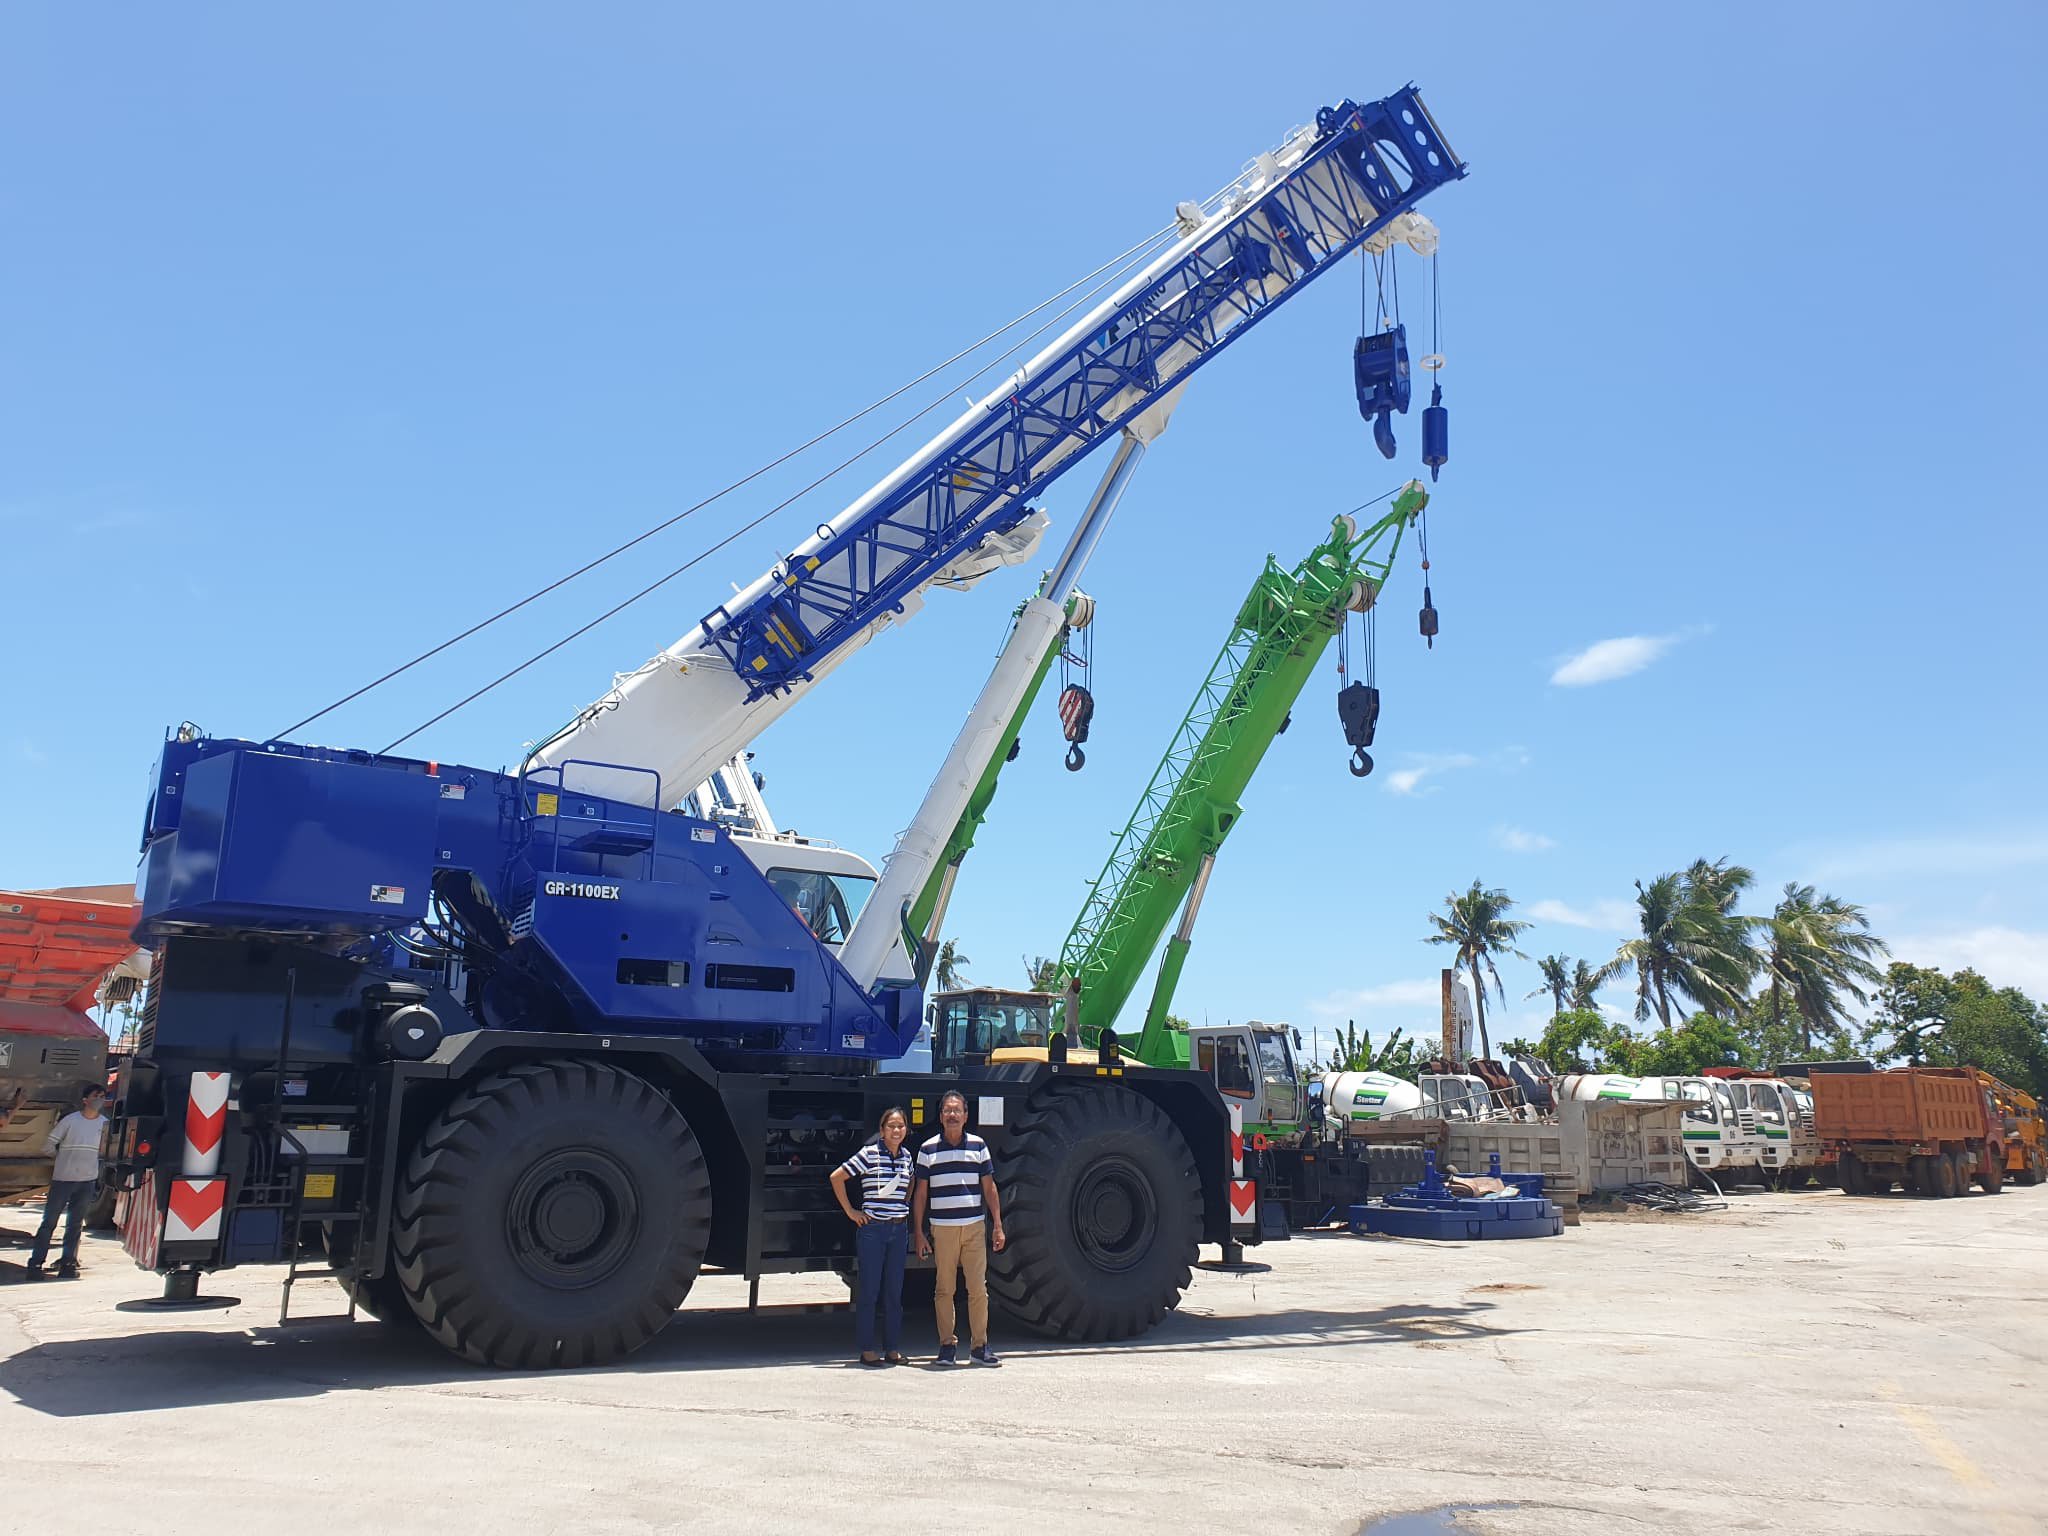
[1059,481,1434,1067]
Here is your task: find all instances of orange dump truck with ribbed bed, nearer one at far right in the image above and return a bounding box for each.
[1810,1067,2005,1198]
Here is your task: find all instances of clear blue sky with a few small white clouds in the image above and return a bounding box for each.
[0,4,2048,1040]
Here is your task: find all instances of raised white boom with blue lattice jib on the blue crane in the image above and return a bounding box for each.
[535,86,1464,805]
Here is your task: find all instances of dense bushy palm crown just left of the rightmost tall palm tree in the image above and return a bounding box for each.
[1595,858,1759,1030]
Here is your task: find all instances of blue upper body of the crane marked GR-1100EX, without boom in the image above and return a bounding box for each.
[135,739,922,1059]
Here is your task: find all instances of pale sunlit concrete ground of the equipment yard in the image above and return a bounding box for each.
[0,1188,2048,1536]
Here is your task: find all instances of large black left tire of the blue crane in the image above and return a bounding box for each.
[391,1061,711,1368]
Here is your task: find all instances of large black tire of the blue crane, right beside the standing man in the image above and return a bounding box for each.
[989,1085,1202,1341]
